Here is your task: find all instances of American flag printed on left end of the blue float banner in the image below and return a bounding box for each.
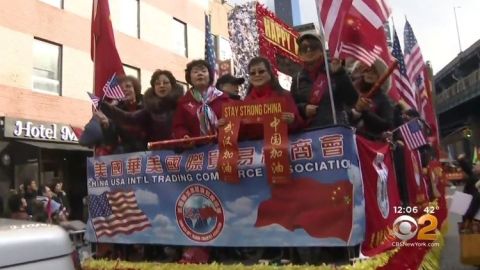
[89,191,152,237]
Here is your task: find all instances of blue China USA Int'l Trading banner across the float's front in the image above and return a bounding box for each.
[87,126,365,246]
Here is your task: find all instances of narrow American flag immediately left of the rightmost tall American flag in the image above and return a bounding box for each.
[392,30,418,110]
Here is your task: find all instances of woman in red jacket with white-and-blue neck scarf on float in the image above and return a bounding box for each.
[173,60,230,139]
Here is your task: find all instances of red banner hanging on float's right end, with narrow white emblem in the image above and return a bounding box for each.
[357,136,402,256]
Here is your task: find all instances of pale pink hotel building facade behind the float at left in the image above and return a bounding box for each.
[0,0,231,218]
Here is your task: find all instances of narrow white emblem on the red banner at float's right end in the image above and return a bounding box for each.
[373,153,390,219]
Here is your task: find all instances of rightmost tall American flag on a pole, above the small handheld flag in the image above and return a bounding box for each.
[403,20,428,110]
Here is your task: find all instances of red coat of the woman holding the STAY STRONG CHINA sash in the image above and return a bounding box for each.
[239,85,304,140]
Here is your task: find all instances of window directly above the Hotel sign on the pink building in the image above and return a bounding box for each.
[32,39,62,95]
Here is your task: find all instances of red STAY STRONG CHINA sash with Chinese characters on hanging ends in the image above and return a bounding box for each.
[218,98,291,184]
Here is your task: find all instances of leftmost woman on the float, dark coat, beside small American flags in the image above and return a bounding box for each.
[79,75,146,155]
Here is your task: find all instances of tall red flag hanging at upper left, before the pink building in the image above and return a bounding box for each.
[90,0,125,97]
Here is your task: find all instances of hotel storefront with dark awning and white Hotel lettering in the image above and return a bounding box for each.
[0,117,92,219]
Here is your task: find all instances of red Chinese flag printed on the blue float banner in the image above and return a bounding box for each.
[255,178,353,242]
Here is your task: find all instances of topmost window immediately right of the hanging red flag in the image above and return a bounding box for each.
[110,0,140,38]
